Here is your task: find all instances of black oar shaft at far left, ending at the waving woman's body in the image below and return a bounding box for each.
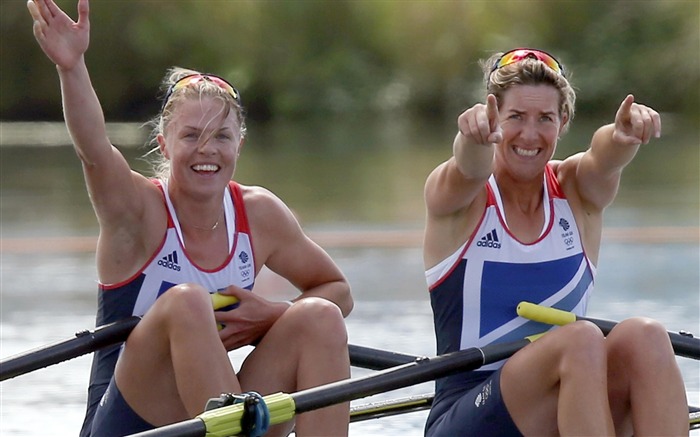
[0,316,140,381]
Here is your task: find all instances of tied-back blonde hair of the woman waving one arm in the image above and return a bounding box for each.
[144,67,247,179]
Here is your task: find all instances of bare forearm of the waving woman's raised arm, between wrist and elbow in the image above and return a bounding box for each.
[57,58,110,165]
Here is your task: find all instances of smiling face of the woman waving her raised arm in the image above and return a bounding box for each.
[158,97,242,195]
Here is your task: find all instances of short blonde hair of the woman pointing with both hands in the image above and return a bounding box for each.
[479,53,576,132]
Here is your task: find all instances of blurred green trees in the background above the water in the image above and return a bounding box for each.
[0,0,700,121]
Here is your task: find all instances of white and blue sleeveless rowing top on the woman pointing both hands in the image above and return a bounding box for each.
[425,165,595,370]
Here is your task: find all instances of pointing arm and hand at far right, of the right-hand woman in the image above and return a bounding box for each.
[562,95,661,211]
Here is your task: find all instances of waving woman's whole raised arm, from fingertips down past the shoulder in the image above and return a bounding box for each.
[27,0,156,279]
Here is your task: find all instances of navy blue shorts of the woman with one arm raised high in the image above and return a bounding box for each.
[90,377,155,437]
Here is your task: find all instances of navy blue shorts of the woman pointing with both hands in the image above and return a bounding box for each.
[425,369,522,437]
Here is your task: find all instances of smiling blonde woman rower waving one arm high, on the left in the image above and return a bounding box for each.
[28,0,353,436]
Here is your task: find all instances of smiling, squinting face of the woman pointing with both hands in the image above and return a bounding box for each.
[496,85,566,179]
